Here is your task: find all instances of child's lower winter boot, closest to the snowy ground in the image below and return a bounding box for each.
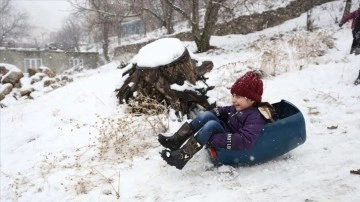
[161,136,203,170]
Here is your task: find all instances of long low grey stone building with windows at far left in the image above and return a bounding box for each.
[0,48,100,73]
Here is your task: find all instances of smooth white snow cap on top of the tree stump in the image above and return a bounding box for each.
[132,38,185,67]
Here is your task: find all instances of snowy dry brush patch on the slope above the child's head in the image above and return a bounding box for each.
[248,29,335,76]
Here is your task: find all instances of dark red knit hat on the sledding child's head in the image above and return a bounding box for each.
[231,71,263,102]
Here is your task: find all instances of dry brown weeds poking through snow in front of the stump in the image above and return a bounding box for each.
[97,96,169,162]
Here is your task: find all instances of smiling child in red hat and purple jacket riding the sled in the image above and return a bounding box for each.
[158,71,265,170]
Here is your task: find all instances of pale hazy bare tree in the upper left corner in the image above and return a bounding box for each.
[0,0,29,44]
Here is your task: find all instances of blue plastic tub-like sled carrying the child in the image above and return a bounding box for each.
[208,100,306,166]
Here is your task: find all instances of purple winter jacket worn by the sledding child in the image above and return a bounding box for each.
[210,106,265,151]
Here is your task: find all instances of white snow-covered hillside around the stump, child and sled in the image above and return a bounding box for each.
[0,1,360,202]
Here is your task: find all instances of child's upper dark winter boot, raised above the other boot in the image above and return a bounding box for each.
[158,123,194,151]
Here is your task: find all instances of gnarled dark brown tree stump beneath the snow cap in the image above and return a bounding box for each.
[115,38,215,115]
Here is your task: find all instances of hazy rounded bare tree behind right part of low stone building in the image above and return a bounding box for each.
[53,17,85,52]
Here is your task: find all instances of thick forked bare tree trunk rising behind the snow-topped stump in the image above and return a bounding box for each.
[165,0,226,52]
